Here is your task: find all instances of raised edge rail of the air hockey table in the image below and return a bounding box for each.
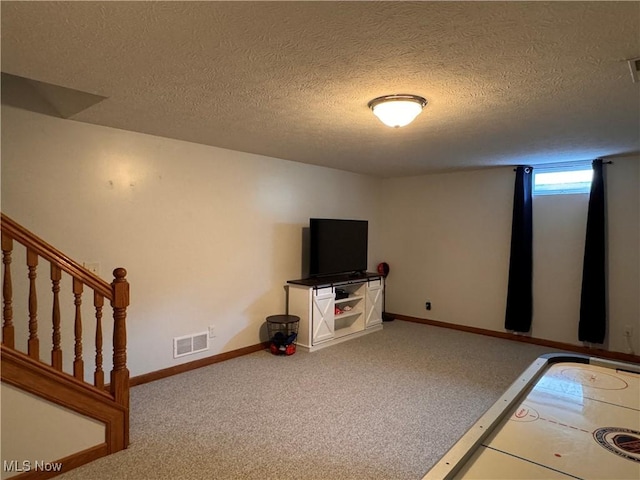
[422,353,640,480]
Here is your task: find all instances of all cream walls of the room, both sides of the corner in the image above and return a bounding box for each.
[2,107,640,375]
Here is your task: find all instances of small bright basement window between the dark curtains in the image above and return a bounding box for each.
[533,163,593,195]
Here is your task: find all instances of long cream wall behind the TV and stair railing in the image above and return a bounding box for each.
[2,106,381,375]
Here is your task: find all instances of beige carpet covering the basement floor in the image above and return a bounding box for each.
[59,320,564,480]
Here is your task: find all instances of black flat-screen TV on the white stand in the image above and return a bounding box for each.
[309,218,369,277]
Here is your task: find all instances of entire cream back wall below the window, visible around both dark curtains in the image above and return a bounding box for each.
[381,157,640,353]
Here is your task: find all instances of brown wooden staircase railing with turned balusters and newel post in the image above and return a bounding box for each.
[2,214,129,460]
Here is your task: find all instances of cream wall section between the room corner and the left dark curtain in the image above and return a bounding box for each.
[382,169,513,329]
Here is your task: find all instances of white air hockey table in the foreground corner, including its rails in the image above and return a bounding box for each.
[423,354,640,480]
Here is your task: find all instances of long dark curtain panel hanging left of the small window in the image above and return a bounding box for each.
[504,167,533,332]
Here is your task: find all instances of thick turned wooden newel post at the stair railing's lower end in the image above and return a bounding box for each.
[111,268,129,448]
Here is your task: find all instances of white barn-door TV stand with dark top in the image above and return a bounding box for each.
[286,272,384,352]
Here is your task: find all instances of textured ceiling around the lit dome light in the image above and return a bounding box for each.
[0,1,640,177]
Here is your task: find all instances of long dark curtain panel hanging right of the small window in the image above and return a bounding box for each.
[578,159,607,343]
